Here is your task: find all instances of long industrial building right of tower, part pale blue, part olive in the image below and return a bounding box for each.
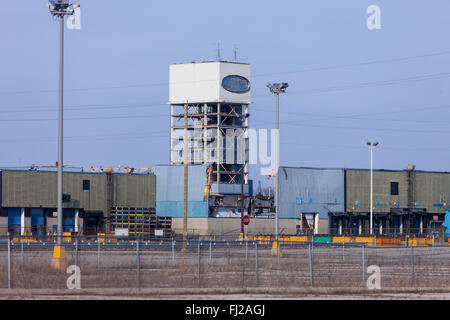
[278,165,450,235]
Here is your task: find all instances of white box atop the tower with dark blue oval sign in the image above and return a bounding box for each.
[169,61,250,104]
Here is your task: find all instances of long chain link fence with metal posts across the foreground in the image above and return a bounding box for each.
[0,237,450,289]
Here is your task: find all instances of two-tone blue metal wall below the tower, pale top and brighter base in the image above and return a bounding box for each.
[153,165,208,217]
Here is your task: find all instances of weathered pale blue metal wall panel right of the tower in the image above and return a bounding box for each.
[278,167,345,218]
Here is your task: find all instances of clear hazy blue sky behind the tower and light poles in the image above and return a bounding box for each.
[0,0,450,184]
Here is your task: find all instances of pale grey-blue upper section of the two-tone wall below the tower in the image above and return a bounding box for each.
[153,165,208,201]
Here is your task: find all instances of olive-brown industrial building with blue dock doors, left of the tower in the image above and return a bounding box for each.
[0,170,156,237]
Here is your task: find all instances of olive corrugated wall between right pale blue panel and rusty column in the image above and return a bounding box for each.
[346,169,408,212]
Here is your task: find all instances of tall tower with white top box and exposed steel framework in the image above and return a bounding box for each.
[169,61,251,216]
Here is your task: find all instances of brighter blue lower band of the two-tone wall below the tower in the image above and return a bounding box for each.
[156,201,208,218]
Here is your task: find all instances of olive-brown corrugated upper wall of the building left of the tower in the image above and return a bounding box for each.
[1,171,156,215]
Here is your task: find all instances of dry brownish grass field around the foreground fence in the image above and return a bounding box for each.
[0,243,450,299]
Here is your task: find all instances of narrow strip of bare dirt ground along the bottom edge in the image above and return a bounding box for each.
[0,288,450,301]
